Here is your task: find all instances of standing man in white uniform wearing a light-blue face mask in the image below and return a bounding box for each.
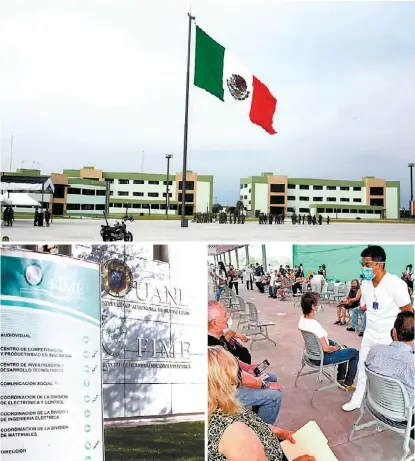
[342,246,413,411]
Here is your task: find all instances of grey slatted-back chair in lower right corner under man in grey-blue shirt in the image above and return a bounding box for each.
[349,366,415,461]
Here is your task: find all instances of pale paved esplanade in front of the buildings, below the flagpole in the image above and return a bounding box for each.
[1,219,415,243]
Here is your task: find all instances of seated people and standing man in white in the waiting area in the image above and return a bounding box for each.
[208,246,415,461]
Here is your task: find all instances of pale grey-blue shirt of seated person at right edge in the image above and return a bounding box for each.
[366,341,415,406]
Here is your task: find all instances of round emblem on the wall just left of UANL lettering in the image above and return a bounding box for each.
[101,259,133,298]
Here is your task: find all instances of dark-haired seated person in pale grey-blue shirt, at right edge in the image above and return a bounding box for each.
[366,311,415,439]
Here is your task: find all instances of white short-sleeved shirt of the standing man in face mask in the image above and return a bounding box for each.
[360,272,411,336]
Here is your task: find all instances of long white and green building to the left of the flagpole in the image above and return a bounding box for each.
[4,166,213,216]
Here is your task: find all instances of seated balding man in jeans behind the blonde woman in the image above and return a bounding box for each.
[208,301,282,424]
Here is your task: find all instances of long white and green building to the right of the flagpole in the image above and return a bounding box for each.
[240,172,400,219]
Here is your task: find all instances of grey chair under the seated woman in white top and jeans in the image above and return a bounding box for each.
[294,330,347,406]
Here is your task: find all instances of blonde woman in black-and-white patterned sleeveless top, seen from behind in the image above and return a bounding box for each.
[208,346,315,461]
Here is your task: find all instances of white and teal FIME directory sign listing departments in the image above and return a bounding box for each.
[0,249,104,461]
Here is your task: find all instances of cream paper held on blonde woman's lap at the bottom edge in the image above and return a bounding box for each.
[281,421,338,461]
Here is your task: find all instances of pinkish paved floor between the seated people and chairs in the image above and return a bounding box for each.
[214,282,412,461]
